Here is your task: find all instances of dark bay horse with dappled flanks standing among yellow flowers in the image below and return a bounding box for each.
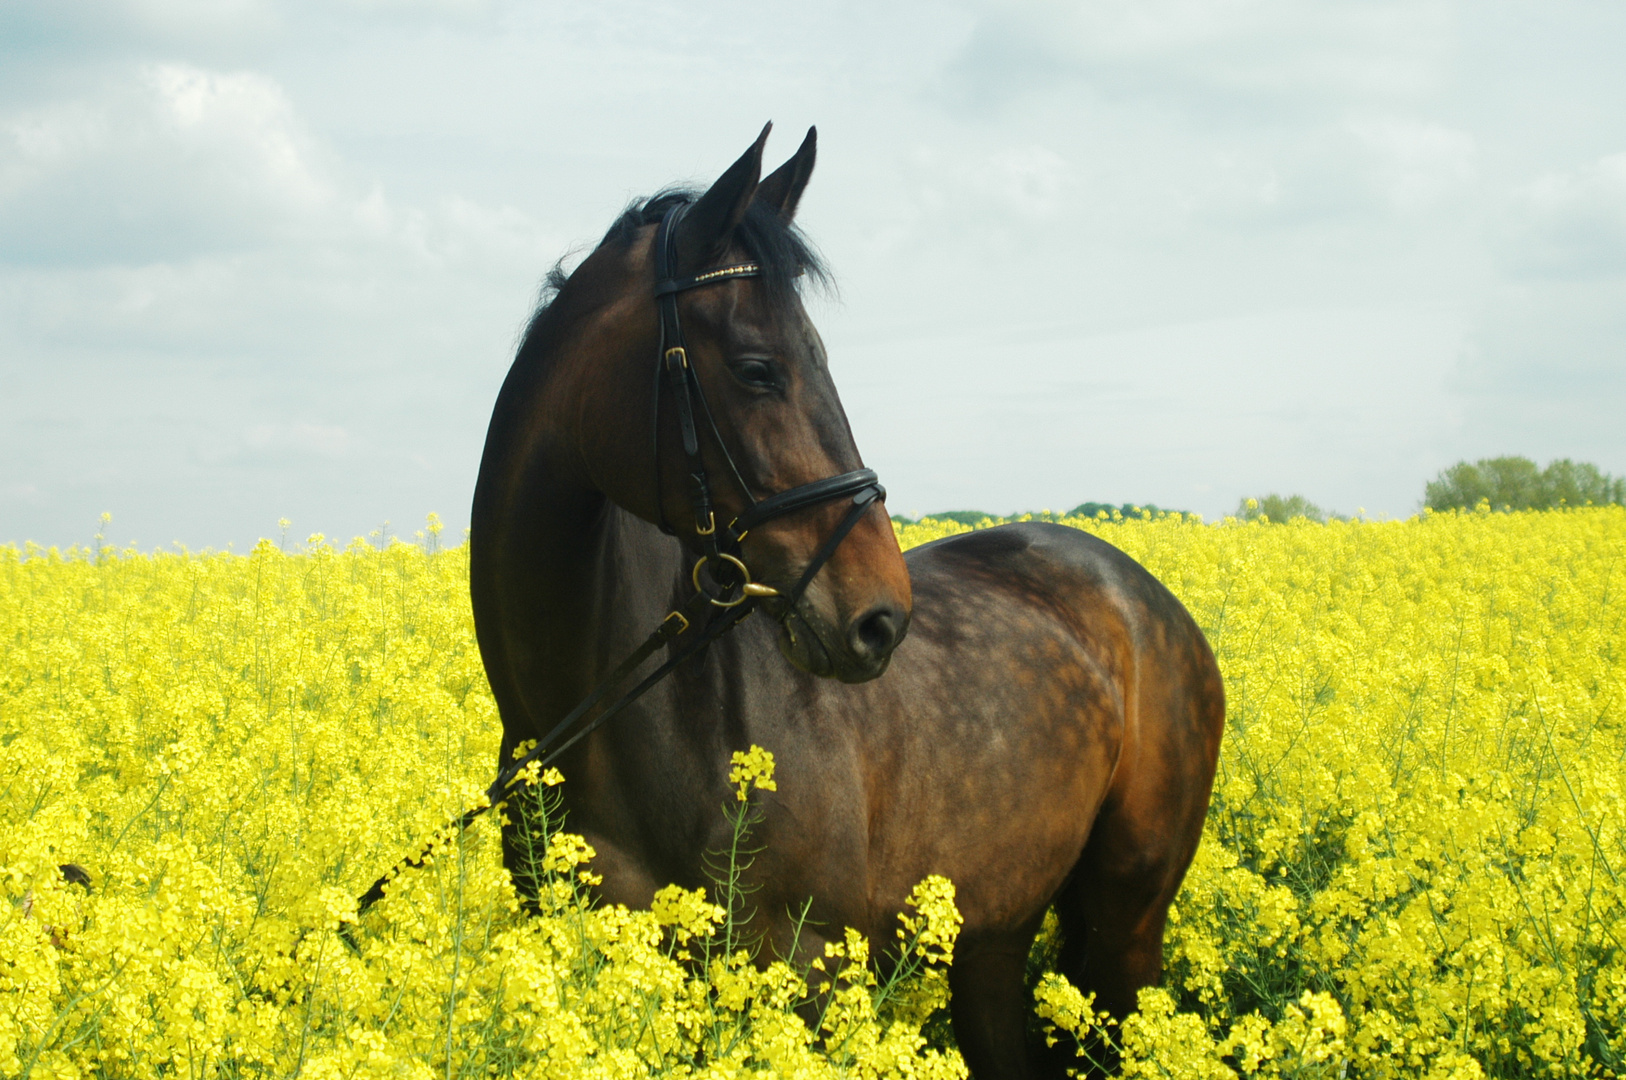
[470,128,1224,1080]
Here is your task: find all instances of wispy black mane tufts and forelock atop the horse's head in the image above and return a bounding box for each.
[525,187,831,338]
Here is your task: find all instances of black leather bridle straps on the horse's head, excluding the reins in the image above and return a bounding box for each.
[655,203,886,621]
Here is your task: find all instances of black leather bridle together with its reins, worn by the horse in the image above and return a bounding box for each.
[352,203,886,923]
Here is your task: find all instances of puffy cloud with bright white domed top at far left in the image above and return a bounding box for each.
[0,65,333,265]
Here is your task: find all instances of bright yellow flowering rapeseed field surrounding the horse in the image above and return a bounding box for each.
[0,509,1626,1078]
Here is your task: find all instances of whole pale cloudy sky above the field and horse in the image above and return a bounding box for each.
[0,0,1626,550]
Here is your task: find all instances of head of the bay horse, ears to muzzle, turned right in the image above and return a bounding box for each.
[559,128,911,682]
